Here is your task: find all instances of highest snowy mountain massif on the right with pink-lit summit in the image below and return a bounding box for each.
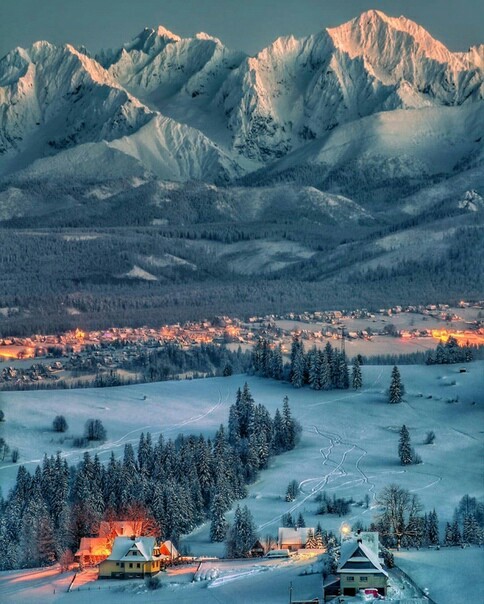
[216,11,483,161]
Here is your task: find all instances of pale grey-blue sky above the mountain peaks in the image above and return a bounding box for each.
[0,0,484,57]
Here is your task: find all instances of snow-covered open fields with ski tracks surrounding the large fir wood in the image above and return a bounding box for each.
[0,362,484,604]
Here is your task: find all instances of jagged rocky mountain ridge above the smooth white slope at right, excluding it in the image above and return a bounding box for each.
[0,10,484,182]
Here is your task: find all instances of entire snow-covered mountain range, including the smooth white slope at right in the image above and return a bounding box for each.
[0,10,484,184]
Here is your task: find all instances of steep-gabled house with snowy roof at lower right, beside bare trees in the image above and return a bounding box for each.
[337,538,388,596]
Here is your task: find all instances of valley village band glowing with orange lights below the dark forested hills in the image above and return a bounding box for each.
[0,301,484,389]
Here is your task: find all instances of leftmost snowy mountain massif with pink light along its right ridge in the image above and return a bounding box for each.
[0,42,152,172]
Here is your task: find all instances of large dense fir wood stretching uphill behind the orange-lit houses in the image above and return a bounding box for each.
[0,385,299,570]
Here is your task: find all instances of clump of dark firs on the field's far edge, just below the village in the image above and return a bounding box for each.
[252,335,363,390]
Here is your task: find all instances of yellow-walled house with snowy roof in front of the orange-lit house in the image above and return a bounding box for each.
[99,537,170,579]
